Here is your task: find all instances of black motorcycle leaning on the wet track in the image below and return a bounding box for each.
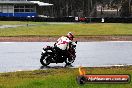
[40,41,77,66]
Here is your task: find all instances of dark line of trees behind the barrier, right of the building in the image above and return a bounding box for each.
[35,0,131,17]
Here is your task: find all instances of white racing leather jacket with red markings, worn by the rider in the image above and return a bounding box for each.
[56,36,72,50]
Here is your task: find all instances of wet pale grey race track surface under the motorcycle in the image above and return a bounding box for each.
[0,41,132,72]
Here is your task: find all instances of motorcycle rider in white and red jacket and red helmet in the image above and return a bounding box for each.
[55,32,74,50]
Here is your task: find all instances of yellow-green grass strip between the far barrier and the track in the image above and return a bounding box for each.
[0,21,132,37]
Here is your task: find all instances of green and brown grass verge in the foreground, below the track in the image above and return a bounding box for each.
[0,66,132,88]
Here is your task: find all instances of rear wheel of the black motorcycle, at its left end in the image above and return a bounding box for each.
[40,54,50,66]
